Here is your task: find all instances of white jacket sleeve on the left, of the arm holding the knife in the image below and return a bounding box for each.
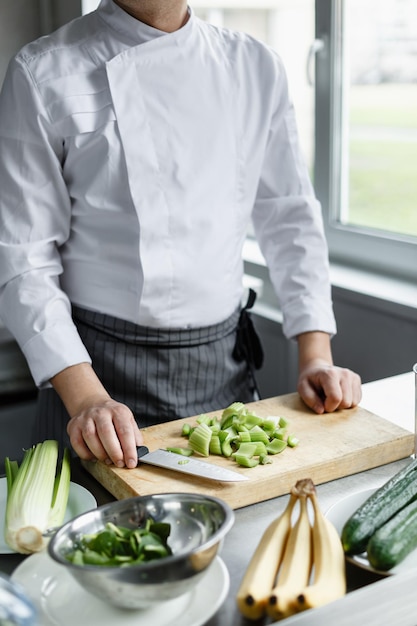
[0,59,89,385]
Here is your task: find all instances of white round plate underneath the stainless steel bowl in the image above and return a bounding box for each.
[12,552,230,626]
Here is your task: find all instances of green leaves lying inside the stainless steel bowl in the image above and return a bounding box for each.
[66,519,172,567]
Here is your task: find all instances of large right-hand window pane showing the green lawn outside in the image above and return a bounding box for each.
[340,0,417,237]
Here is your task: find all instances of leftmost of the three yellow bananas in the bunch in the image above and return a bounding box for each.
[236,493,297,620]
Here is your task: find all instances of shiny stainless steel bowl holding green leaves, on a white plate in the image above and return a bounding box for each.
[48,493,234,609]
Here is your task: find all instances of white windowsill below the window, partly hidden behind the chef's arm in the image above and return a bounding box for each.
[243,239,417,312]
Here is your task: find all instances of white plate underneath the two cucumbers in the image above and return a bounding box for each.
[326,489,417,576]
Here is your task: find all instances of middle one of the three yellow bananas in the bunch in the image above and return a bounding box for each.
[267,488,312,620]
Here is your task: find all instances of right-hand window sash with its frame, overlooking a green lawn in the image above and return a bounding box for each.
[315,0,417,280]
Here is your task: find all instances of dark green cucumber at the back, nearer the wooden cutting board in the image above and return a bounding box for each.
[341,459,417,554]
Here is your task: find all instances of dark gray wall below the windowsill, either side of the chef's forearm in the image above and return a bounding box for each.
[254,288,417,398]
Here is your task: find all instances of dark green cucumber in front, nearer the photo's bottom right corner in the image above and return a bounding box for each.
[366,501,417,572]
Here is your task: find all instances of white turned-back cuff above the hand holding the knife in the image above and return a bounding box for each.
[22,322,91,389]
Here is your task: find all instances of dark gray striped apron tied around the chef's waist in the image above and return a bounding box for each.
[34,298,260,446]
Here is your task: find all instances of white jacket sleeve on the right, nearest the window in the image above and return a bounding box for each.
[253,55,336,337]
